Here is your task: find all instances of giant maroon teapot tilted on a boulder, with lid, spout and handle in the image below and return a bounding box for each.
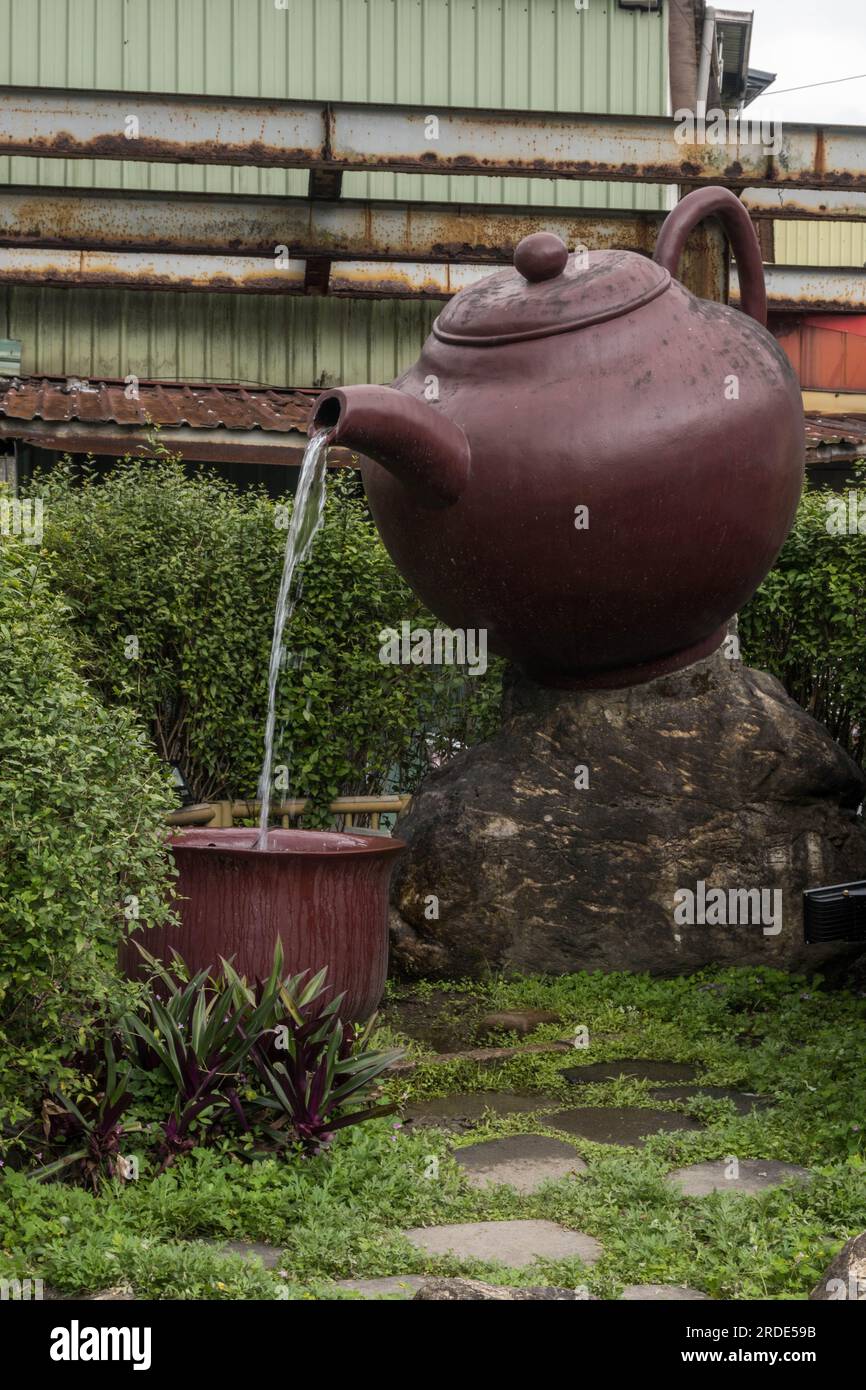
[311,188,805,687]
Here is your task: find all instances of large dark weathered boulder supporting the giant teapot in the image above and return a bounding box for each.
[392,649,866,977]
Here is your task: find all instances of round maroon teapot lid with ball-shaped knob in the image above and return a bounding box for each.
[432,232,670,348]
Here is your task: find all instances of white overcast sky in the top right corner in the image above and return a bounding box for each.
[745,0,866,125]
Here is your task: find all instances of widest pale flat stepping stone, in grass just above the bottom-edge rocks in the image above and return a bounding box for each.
[403,1220,602,1269]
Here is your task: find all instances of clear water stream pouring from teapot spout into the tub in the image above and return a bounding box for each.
[256,430,328,849]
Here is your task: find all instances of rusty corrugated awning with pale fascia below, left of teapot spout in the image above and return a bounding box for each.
[0,377,328,464]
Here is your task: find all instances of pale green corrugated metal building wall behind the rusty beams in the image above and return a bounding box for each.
[0,0,670,385]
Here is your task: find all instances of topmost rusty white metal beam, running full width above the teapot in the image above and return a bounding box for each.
[0,86,866,192]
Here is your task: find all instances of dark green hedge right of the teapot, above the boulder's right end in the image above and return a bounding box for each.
[740,475,866,763]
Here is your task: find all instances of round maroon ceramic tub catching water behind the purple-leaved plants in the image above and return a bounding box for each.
[121,830,405,1022]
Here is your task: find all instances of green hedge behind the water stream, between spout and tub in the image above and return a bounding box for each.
[33,457,499,817]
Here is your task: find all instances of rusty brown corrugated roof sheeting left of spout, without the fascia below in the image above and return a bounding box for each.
[0,377,318,434]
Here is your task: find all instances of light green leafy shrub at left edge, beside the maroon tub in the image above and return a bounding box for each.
[0,537,172,1127]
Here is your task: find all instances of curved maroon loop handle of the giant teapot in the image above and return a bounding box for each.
[653,188,767,328]
